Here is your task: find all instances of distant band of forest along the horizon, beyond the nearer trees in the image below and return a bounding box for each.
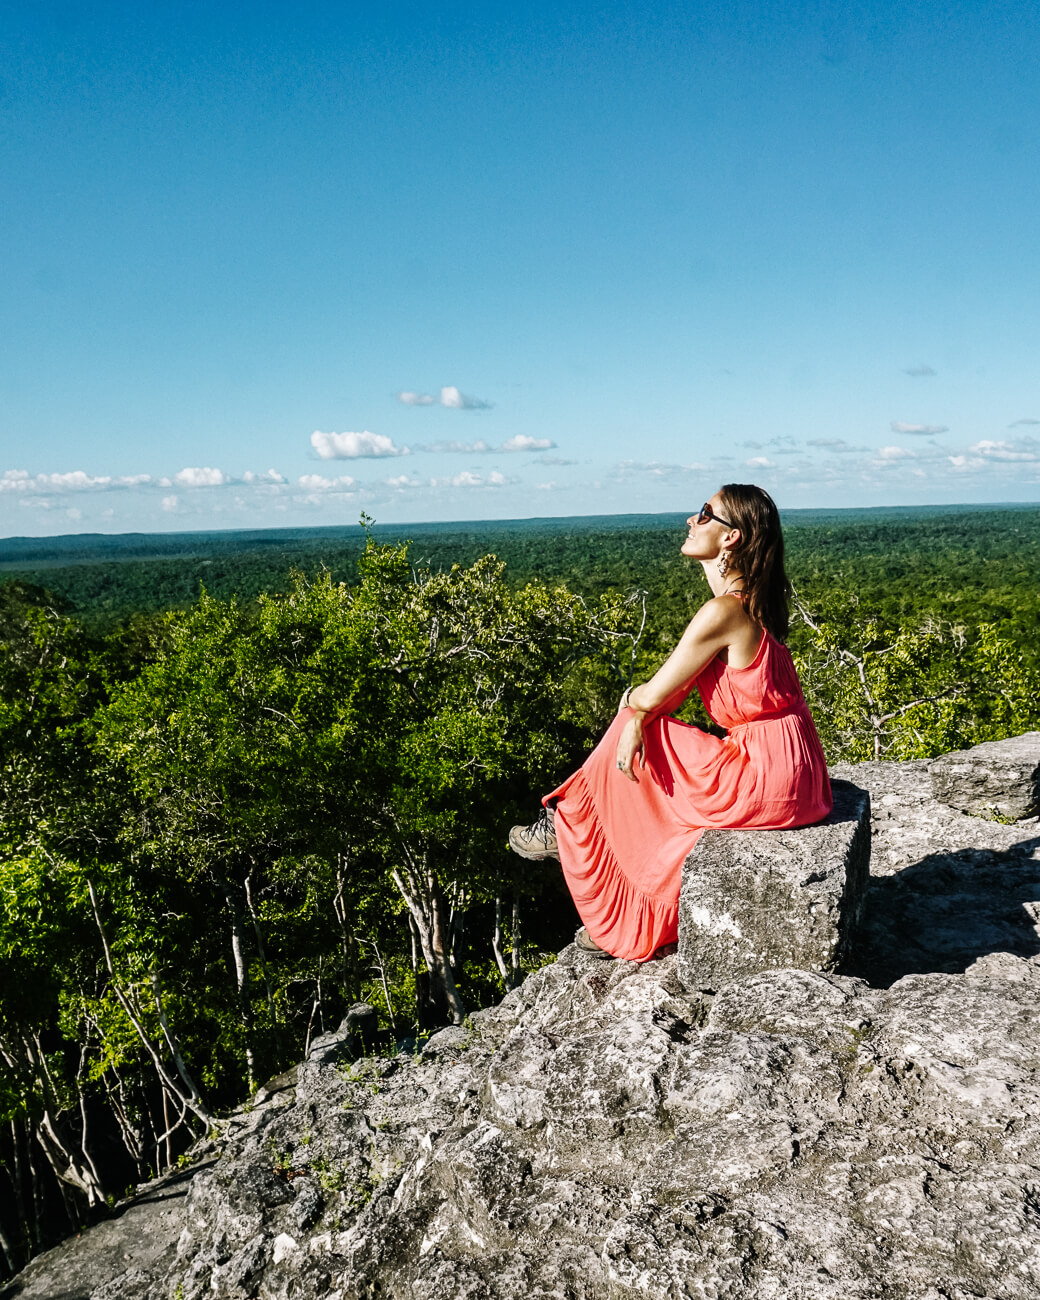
[0,506,1040,634]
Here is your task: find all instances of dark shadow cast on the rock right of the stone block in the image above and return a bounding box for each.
[845,837,1040,988]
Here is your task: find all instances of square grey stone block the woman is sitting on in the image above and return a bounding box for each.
[679,780,870,989]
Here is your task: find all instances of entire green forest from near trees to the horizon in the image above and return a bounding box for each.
[0,507,1040,1271]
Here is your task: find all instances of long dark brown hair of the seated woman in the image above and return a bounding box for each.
[719,484,790,641]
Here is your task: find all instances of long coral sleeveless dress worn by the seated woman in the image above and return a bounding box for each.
[543,632,831,962]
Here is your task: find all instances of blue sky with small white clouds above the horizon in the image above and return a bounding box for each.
[0,0,1040,536]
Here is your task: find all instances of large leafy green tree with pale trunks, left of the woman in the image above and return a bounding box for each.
[99,542,638,1055]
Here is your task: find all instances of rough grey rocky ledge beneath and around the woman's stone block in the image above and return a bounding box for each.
[6,743,1040,1300]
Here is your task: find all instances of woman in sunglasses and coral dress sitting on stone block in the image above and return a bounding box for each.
[510,484,831,961]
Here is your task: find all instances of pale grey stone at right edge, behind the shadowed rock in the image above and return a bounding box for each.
[930,732,1040,822]
